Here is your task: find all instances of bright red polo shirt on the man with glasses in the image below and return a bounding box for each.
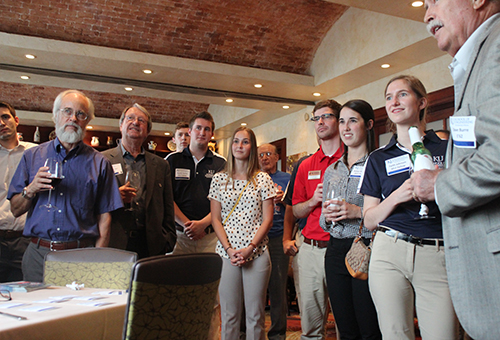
[292,145,344,241]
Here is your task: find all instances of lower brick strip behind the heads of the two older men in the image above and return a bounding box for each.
[0,82,208,124]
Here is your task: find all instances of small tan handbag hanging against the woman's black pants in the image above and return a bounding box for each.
[345,220,375,280]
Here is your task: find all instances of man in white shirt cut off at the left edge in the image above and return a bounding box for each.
[0,101,36,282]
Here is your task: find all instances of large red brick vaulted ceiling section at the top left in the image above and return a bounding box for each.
[0,0,346,74]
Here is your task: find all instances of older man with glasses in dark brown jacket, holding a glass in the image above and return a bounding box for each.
[103,104,176,259]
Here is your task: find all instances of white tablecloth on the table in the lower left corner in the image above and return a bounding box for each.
[0,287,128,340]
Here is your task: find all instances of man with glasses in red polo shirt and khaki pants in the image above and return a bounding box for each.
[292,100,344,339]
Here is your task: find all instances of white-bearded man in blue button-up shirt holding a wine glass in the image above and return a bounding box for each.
[7,90,123,282]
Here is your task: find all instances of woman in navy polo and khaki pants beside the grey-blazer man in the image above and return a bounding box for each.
[360,75,458,340]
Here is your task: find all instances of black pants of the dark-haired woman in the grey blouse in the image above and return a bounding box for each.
[325,237,382,340]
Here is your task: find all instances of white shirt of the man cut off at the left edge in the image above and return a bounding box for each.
[0,142,37,230]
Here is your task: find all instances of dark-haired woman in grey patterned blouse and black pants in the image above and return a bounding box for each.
[320,99,382,340]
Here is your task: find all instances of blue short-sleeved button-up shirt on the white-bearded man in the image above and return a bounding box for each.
[7,139,123,241]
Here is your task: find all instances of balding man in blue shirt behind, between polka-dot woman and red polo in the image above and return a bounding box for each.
[258,144,290,340]
